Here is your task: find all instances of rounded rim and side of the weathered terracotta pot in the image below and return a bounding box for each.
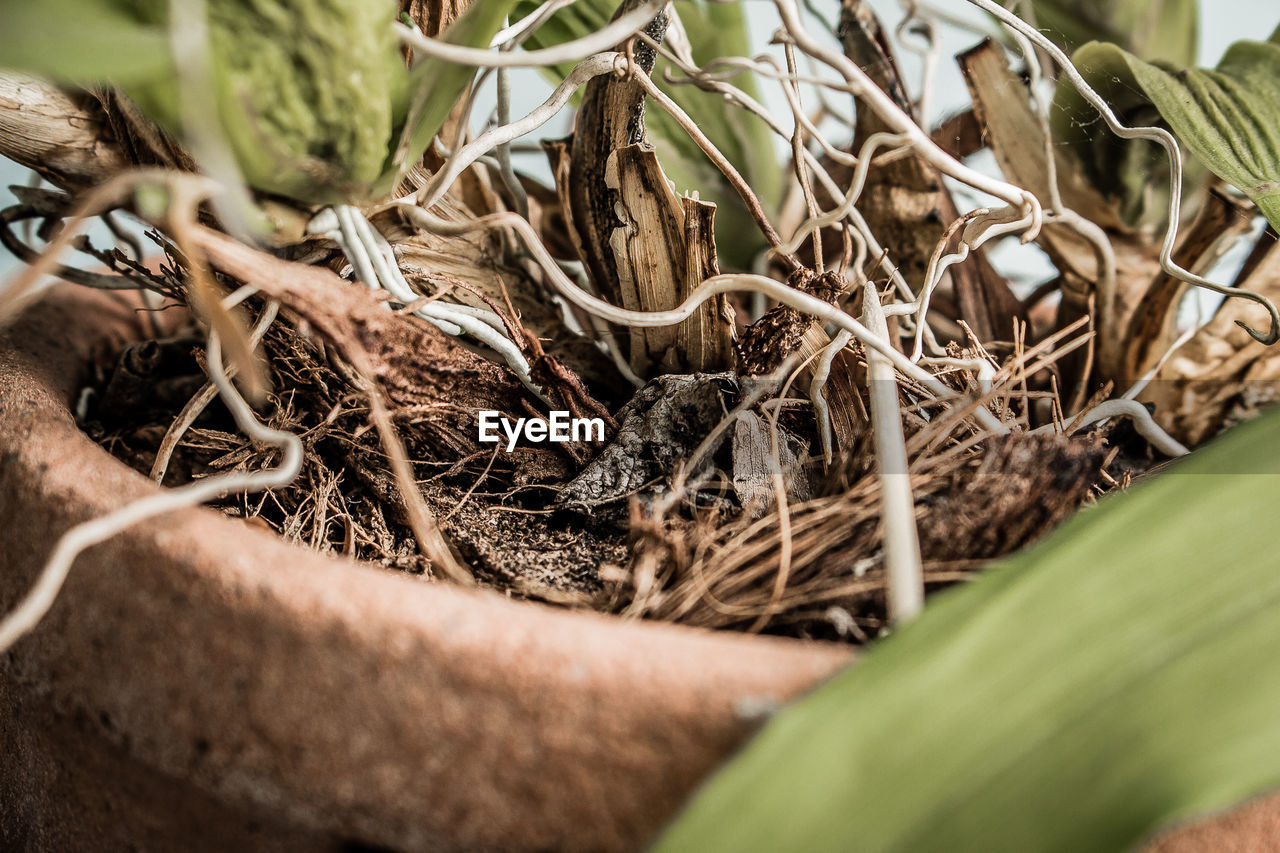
[0,289,849,850]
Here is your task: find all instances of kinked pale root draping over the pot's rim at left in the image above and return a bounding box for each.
[0,326,302,653]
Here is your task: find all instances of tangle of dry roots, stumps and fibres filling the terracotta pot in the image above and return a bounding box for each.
[0,0,1280,642]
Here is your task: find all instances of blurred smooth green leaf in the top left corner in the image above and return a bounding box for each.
[0,0,172,83]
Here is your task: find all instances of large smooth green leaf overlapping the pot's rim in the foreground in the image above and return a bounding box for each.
[657,412,1280,853]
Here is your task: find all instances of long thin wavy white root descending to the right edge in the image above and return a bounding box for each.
[967,0,1280,345]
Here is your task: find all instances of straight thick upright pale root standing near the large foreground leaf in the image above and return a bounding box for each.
[863,282,924,625]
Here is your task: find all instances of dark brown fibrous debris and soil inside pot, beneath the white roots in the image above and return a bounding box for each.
[84,290,1131,642]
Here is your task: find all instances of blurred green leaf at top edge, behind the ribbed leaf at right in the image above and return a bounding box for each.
[1032,0,1199,65]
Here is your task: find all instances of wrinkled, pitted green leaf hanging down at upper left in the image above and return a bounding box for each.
[192,0,406,204]
